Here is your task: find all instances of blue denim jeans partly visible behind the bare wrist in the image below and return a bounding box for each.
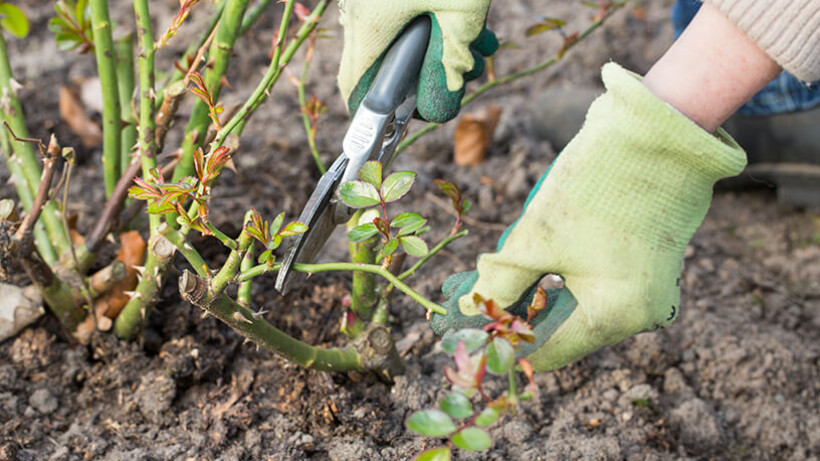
[672,0,820,116]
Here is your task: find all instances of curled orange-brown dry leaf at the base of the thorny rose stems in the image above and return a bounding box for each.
[94,231,147,331]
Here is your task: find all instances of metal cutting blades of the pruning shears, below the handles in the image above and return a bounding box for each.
[275,154,348,294]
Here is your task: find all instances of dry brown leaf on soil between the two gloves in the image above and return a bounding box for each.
[454,104,501,166]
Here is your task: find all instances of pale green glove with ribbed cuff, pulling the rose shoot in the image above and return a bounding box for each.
[432,63,746,371]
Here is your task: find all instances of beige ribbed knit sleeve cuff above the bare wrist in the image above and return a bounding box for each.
[705,0,820,82]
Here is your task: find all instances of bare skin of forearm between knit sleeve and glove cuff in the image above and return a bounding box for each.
[643,4,781,132]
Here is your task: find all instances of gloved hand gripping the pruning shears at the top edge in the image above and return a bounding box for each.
[339,0,498,123]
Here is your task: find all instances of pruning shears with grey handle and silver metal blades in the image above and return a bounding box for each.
[276,17,431,294]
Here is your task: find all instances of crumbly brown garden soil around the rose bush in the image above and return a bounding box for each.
[0,0,820,461]
